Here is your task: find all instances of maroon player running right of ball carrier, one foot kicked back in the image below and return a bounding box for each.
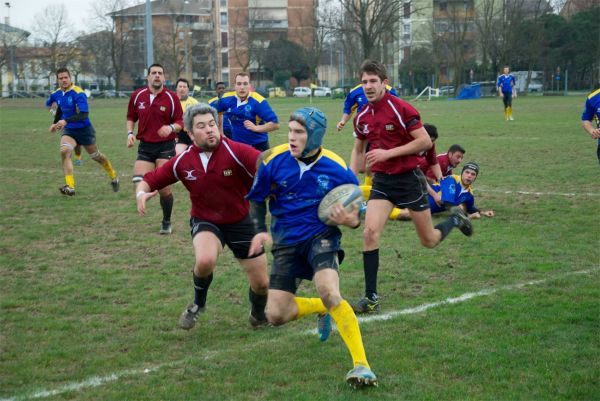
[351,60,472,313]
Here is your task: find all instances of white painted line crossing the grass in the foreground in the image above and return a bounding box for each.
[0,267,600,401]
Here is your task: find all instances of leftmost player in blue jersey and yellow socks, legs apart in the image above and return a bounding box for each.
[46,67,119,196]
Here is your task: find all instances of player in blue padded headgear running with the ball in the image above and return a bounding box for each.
[247,107,377,386]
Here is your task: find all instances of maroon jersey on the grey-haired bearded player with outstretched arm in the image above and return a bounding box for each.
[144,137,260,224]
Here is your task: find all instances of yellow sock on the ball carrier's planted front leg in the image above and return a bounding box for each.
[329,300,370,368]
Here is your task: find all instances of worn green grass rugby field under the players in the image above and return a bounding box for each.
[0,96,600,401]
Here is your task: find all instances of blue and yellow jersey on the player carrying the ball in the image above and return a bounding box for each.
[246,143,358,245]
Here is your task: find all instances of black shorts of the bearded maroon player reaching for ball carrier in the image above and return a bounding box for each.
[190,215,265,259]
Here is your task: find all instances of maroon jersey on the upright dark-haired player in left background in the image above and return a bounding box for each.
[127,86,183,142]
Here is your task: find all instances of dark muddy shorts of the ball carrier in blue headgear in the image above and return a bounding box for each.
[269,227,343,294]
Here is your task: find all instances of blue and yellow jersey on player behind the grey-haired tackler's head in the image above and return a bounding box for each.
[211,92,279,145]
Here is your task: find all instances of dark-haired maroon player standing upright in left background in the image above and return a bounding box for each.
[127,63,183,234]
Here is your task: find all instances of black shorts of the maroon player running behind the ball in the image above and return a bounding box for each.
[369,168,429,212]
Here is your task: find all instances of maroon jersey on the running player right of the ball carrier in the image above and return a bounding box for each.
[354,92,423,174]
